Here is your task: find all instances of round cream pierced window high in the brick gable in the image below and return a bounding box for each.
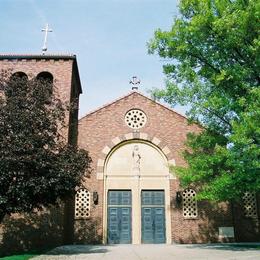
[125,109,147,129]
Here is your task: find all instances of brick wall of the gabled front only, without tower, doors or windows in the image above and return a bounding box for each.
[75,92,259,243]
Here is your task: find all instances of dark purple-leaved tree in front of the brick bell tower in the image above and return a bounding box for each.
[0,73,90,223]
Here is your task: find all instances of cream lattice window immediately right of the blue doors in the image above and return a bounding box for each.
[182,189,198,218]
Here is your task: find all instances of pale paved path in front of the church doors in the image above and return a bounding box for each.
[33,244,260,260]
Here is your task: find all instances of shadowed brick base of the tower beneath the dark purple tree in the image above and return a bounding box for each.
[0,207,63,256]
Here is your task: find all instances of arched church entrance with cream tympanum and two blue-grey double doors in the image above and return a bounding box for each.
[103,140,171,244]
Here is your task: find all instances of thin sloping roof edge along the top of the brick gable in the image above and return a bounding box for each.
[79,90,187,121]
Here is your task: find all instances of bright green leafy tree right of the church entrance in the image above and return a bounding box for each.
[149,0,260,201]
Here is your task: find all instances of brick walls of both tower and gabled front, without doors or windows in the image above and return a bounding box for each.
[0,55,260,253]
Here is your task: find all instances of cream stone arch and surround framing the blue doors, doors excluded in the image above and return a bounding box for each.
[100,132,175,244]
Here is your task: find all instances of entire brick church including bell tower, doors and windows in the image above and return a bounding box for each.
[0,55,260,255]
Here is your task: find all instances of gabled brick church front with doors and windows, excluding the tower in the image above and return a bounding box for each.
[75,91,259,244]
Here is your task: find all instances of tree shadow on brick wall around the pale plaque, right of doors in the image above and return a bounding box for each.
[175,201,260,243]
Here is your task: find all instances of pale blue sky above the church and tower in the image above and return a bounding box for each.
[0,0,182,117]
